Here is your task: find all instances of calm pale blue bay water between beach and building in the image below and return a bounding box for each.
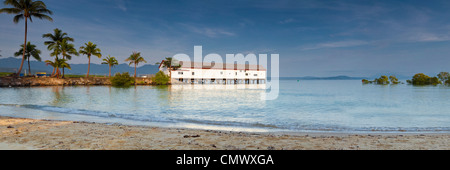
[0,80,450,133]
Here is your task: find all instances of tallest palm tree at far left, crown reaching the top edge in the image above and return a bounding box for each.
[0,0,53,75]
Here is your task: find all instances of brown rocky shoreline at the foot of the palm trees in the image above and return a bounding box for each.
[0,77,152,87]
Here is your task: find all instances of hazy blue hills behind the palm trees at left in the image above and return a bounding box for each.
[0,57,159,75]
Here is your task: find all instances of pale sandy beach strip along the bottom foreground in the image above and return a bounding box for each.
[0,117,450,150]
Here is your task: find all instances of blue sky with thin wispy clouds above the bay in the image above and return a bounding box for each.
[0,0,450,77]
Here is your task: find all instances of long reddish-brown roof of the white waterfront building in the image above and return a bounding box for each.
[160,60,266,71]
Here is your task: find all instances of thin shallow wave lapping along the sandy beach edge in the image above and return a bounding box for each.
[0,104,450,133]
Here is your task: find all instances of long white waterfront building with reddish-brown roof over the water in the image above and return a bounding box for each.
[159,60,267,84]
